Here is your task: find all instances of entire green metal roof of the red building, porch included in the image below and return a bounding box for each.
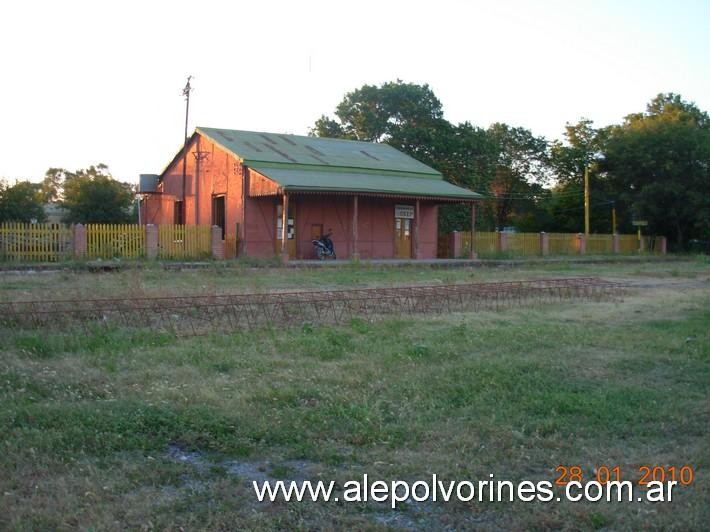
[196,127,482,200]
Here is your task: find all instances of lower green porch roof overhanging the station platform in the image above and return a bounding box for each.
[252,165,481,200]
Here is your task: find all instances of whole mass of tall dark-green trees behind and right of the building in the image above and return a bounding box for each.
[312,80,710,246]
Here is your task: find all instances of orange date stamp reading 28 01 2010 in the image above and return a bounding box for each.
[555,465,695,486]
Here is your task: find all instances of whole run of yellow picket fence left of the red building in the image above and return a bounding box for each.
[0,223,217,262]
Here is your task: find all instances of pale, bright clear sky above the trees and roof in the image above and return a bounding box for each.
[0,0,710,182]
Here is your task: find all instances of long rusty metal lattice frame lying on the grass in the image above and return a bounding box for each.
[0,277,624,336]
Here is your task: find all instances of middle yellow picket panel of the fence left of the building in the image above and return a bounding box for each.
[86,224,145,259]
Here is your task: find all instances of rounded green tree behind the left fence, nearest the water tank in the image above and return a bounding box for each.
[61,164,135,224]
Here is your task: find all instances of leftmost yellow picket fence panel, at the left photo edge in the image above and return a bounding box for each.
[0,222,73,262]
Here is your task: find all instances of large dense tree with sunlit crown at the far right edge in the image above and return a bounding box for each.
[600,93,710,248]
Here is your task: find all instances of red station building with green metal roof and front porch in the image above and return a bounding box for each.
[140,127,481,259]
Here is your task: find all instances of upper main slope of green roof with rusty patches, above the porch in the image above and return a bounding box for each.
[197,127,441,176]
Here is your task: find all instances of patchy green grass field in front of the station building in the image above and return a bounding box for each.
[0,260,710,530]
